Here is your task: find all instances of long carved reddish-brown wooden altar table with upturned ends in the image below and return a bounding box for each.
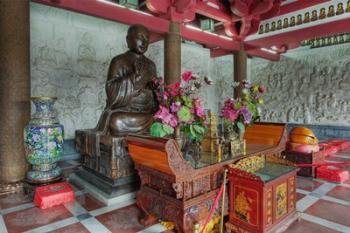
[127,123,286,232]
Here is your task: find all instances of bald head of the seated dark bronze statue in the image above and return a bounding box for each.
[126,24,149,54]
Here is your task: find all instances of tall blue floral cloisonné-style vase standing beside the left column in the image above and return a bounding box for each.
[24,96,64,183]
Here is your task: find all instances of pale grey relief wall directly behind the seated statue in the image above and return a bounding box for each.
[30,3,233,139]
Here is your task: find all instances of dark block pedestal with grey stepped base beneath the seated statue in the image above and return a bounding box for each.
[70,129,139,204]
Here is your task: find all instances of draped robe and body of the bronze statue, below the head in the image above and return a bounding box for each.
[95,52,156,134]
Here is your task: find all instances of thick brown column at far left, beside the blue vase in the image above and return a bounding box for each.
[0,0,30,194]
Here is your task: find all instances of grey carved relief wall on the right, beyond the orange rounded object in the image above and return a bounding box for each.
[249,44,350,126]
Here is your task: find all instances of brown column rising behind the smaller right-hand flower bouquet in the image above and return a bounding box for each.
[233,43,247,98]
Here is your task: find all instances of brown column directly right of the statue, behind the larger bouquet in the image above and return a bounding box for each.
[164,21,181,84]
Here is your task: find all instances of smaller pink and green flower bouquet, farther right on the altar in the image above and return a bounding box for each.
[222,81,265,137]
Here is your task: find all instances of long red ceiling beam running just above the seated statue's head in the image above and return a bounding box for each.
[32,0,239,51]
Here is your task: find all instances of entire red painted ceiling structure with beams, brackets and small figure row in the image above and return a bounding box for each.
[32,0,350,60]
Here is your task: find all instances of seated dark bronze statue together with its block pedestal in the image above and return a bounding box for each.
[75,25,157,195]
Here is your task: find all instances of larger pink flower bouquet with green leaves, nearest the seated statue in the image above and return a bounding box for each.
[150,71,206,141]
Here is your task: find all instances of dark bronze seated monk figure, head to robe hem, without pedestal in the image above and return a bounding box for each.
[96,25,157,136]
